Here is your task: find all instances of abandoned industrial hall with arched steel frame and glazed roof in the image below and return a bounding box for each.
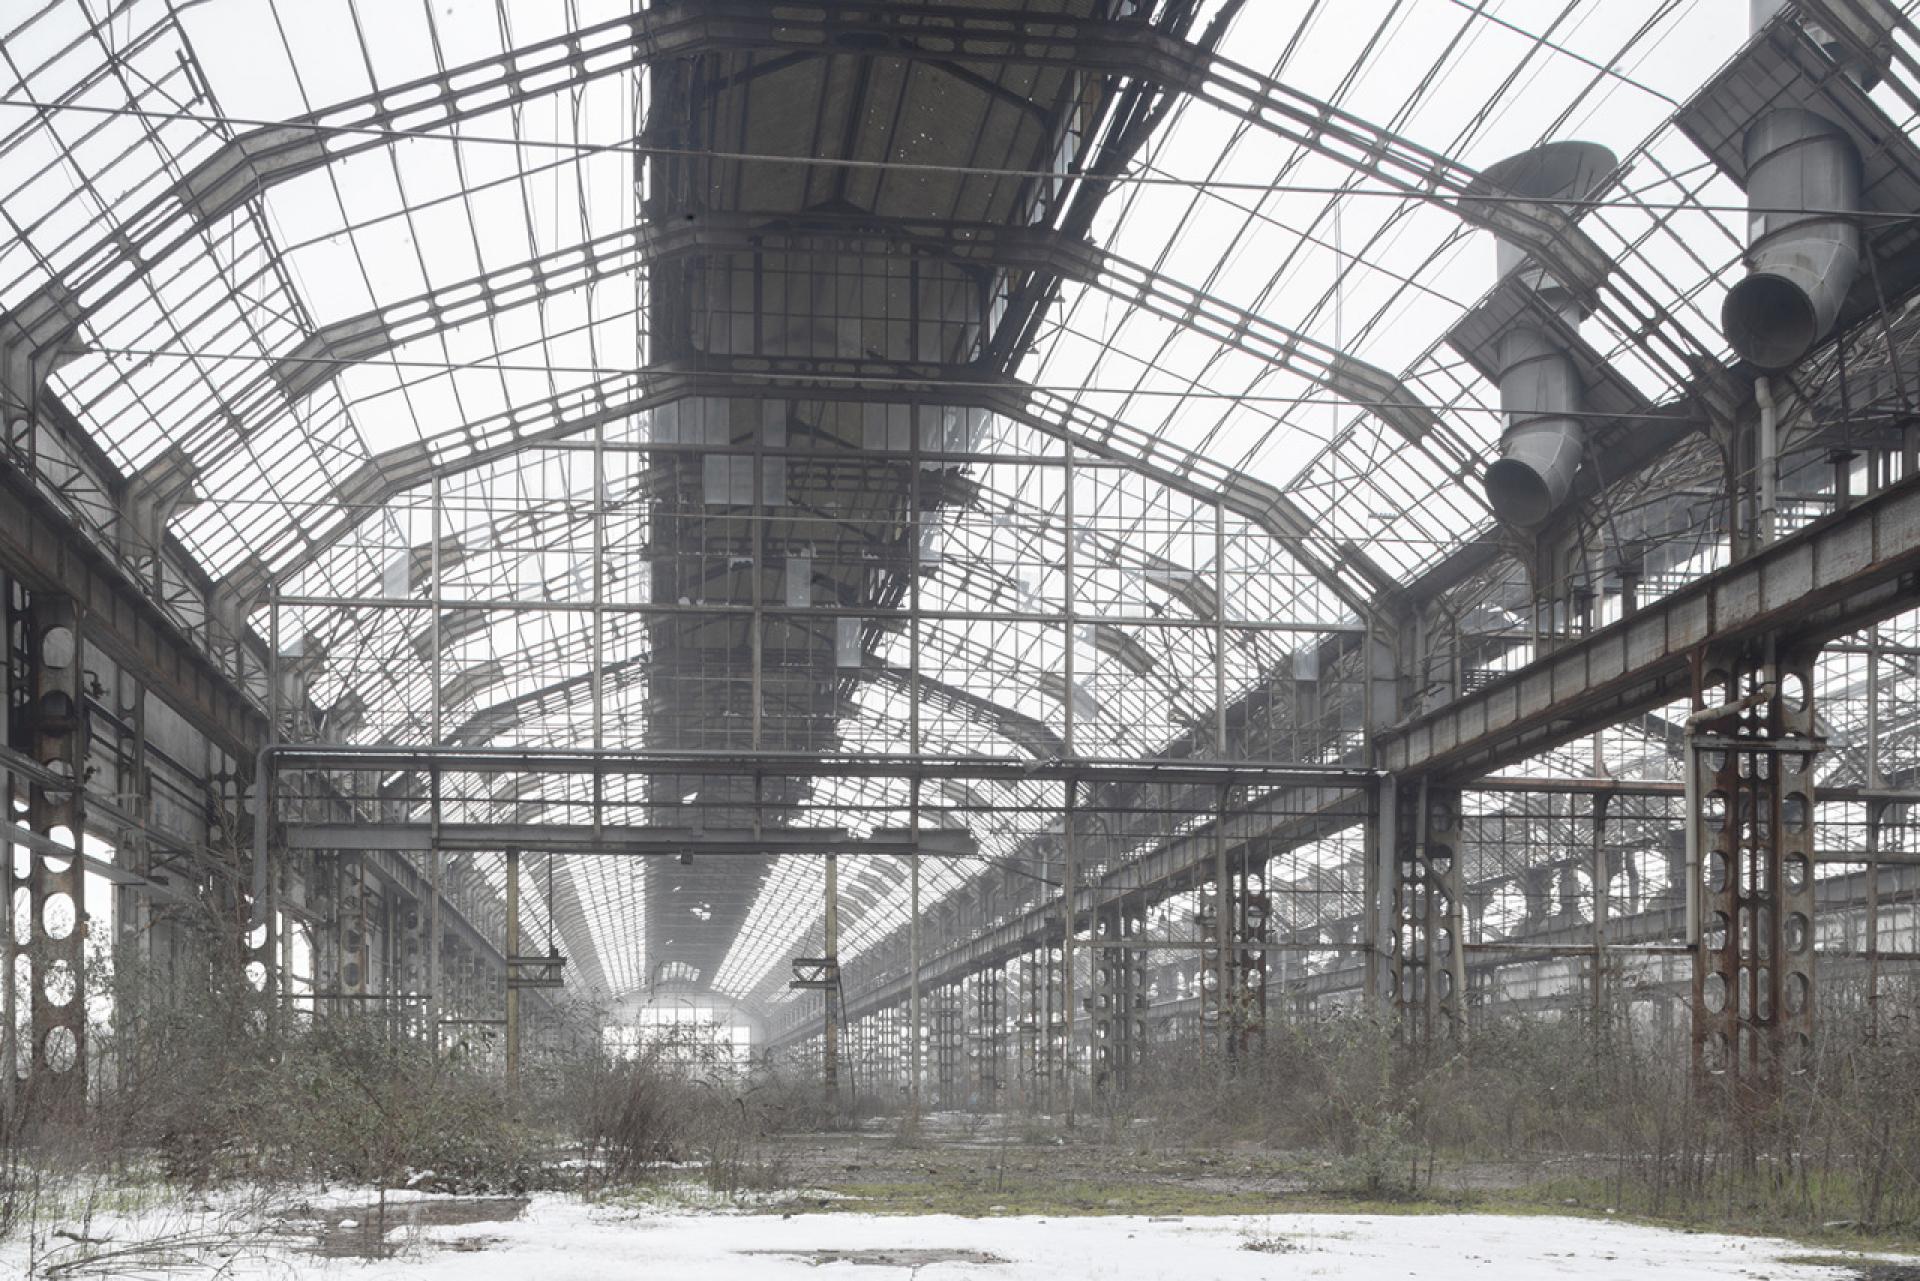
[0,0,1920,1275]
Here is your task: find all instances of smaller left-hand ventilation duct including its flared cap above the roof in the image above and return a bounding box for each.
[1473,142,1615,526]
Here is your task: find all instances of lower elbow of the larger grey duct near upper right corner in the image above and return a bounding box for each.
[1720,109,1860,371]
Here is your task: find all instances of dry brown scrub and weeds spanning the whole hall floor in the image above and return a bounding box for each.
[0,910,1920,1241]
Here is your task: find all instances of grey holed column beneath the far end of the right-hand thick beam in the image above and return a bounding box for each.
[1392,782,1467,1041]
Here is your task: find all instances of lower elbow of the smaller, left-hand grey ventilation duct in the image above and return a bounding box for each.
[1486,326,1586,526]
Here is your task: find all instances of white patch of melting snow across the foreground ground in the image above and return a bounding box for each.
[11,1195,1904,1281]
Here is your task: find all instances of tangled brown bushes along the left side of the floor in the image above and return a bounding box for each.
[0,933,824,1239]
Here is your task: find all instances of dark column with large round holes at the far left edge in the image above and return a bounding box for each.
[8,595,88,1112]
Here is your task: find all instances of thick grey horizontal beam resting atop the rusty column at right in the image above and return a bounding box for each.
[1379,478,1920,780]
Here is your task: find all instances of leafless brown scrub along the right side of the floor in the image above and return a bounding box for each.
[1100,983,1920,1237]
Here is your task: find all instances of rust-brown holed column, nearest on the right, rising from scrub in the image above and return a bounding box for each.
[1688,651,1818,1102]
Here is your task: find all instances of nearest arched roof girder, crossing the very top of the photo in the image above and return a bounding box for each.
[18,0,1666,387]
